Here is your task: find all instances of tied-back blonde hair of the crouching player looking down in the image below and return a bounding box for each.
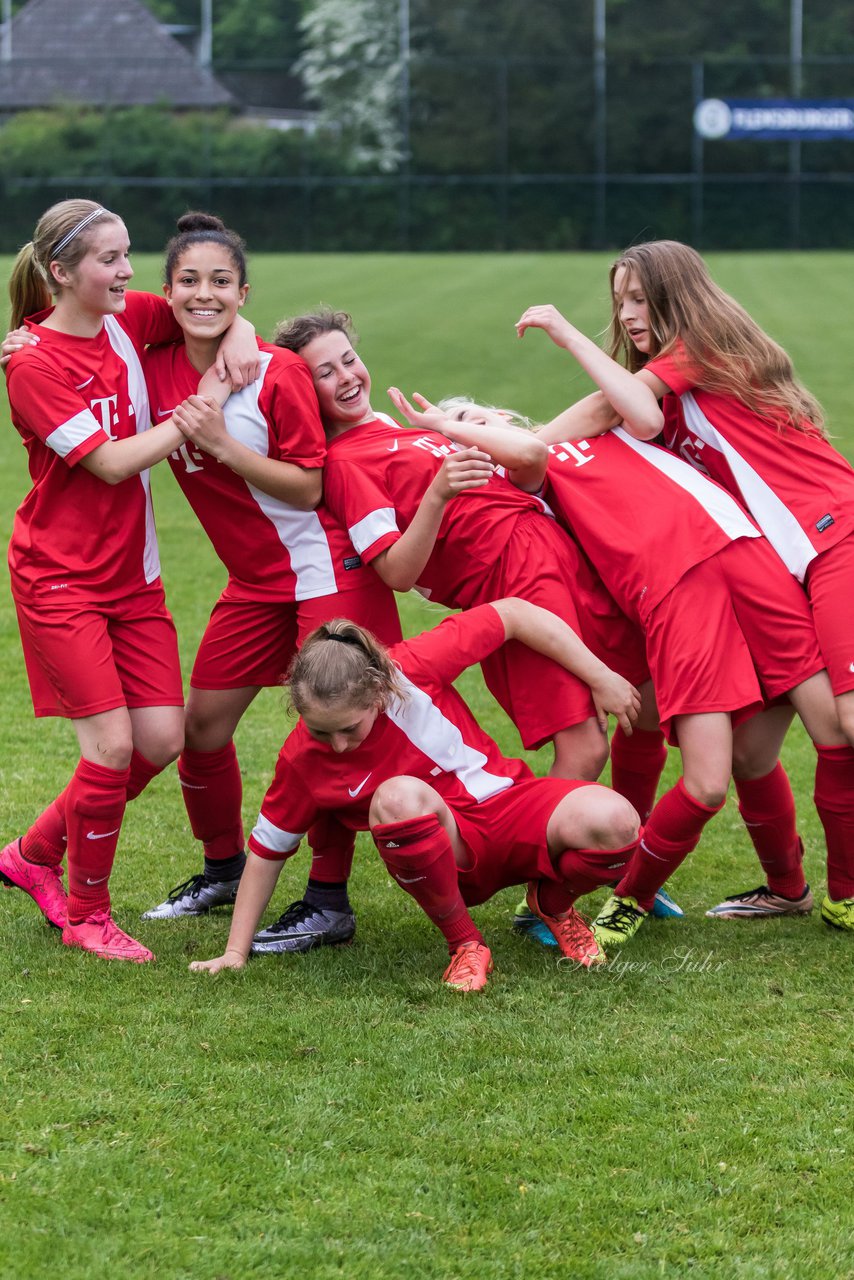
[287,618,403,716]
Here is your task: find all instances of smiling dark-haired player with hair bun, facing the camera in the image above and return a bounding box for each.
[136,212,401,925]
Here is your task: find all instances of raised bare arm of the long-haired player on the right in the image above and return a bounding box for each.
[516,303,665,440]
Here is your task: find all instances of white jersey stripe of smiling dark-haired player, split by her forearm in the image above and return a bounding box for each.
[223,351,338,600]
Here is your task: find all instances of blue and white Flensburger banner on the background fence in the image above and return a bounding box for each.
[694,97,854,142]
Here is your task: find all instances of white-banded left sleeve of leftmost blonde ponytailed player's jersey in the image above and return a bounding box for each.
[8,348,110,467]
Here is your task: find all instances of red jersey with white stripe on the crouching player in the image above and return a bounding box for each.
[250,604,533,859]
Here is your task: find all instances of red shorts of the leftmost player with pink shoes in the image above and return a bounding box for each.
[15,582,184,719]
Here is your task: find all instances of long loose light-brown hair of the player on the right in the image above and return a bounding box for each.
[609,241,826,435]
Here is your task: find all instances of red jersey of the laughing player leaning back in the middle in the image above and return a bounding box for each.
[324,419,551,609]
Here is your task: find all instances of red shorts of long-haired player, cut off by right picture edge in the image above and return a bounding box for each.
[804,536,854,696]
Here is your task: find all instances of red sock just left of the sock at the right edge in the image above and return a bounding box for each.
[735,760,807,897]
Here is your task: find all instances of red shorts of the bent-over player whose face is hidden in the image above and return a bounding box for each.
[647,538,825,741]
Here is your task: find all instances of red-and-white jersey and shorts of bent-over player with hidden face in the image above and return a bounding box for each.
[545,428,822,730]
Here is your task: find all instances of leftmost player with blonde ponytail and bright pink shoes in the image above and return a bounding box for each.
[0,200,256,963]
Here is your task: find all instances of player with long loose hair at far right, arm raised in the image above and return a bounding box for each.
[517,285,854,929]
